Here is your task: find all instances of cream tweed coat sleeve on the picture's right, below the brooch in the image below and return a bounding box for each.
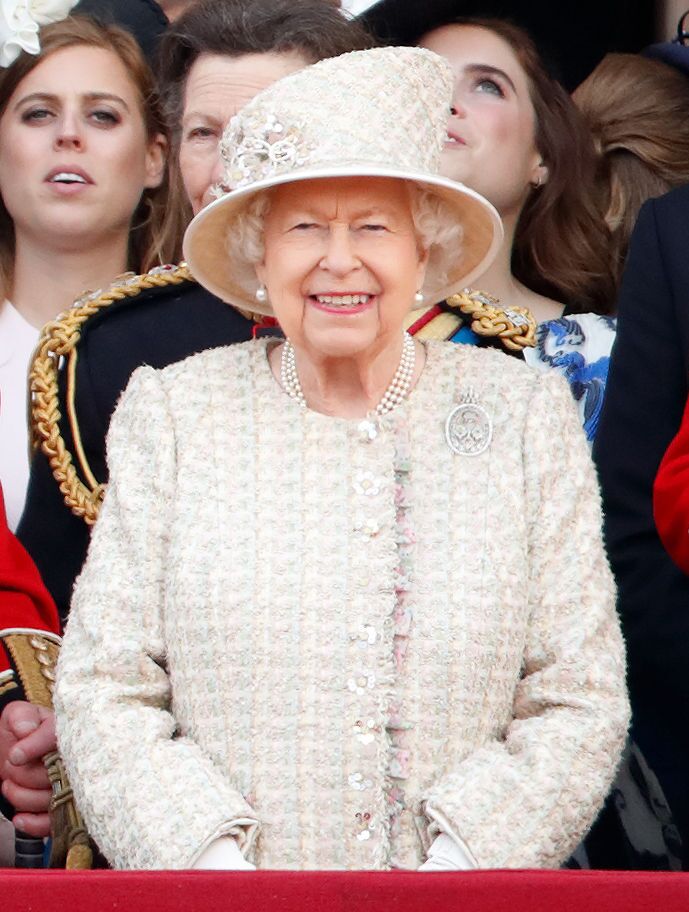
[422,376,628,868]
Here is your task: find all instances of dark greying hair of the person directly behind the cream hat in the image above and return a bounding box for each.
[157,0,374,232]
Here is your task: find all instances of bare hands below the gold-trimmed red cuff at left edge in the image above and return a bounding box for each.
[0,700,57,837]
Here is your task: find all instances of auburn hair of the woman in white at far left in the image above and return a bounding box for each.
[0,16,178,294]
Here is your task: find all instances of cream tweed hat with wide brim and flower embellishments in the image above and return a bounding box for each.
[184,47,503,314]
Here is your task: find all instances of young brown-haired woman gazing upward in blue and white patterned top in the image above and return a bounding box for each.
[420,19,615,439]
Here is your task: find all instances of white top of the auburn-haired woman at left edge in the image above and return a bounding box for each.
[0,301,40,531]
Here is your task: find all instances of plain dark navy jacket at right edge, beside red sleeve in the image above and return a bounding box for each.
[593,187,689,864]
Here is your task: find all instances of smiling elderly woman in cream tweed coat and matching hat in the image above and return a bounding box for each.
[56,49,627,870]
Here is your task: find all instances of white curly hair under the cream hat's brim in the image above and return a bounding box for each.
[226,182,464,300]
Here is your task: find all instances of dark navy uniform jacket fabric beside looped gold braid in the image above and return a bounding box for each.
[17,282,255,623]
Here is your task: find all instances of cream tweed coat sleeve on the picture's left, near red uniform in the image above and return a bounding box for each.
[55,368,257,868]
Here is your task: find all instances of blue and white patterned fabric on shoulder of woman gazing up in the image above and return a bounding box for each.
[524,314,616,443]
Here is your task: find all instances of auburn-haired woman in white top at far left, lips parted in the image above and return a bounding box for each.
[0,17,174,527]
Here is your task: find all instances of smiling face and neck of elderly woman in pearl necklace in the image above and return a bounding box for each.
[256,178,428,398]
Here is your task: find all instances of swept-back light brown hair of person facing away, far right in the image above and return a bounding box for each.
[572,54,689,280]
